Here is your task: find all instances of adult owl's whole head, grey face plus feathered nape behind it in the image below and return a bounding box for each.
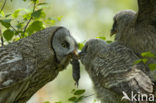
[33,26,78,70]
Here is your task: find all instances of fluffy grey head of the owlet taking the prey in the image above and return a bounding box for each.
[79,39,107,65]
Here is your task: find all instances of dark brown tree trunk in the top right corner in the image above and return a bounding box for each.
[136,0,156,25]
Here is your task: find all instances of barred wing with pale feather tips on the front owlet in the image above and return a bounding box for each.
[92,47,153,93]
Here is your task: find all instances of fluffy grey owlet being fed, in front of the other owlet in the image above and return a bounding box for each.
[80,39,153,103]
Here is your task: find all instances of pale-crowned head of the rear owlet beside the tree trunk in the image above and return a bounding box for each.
[111,10,136,36]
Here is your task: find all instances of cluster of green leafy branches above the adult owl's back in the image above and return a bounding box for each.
[0,0,62,43]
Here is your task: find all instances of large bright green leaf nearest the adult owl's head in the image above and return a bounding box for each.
[27,20,44,35]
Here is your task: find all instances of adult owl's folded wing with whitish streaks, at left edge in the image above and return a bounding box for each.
[0,48,33,89]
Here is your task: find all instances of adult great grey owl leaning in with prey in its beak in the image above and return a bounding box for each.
[0,26,77,103]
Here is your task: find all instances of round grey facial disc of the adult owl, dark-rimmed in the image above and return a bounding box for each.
[51,27,78,64]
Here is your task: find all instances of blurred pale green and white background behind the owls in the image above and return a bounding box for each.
[0,0,137,103]
